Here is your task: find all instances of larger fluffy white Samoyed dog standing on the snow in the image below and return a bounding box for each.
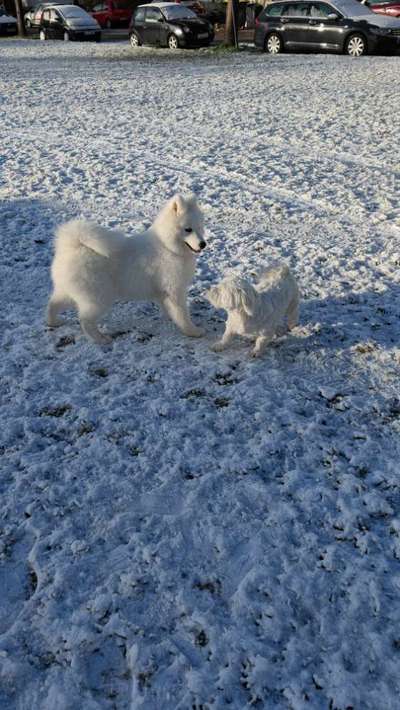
[47,195,206,344]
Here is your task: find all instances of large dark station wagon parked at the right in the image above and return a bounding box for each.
[254,0,400,57]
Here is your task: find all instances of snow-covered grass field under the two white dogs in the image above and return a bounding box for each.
[0,41,400,710]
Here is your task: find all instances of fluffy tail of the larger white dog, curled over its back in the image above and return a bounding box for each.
[55,219,126,258]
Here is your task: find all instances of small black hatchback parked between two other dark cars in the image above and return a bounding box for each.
[129,2,214,49]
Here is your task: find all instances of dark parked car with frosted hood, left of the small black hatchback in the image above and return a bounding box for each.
[39,5,101,42]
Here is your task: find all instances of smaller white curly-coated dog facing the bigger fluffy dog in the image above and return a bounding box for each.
[206,264,299,356]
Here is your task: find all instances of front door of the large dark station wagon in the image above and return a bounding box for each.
[308,2,345,50]
